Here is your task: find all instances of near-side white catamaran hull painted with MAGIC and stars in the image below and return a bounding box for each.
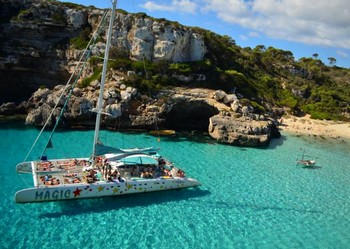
[15,178,200,203]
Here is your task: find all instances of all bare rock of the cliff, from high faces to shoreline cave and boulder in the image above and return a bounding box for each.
[0,0,278,146]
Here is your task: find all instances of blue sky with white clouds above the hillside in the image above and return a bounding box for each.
[58,0,350,68]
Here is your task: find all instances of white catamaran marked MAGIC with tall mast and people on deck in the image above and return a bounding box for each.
[15,0,200,203]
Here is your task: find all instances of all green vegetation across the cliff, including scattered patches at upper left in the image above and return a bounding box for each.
[3,0,350,120]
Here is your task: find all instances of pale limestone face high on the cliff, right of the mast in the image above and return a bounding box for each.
[112,13,206,62]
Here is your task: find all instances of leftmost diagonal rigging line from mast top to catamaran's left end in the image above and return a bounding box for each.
[23,10,108,162]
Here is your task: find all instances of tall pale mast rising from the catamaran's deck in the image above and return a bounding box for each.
[92,0,117,158]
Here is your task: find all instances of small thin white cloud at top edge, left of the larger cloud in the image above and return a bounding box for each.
[141,0,198,14]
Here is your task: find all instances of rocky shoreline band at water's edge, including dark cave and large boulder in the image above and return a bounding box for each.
[0,86,280,147]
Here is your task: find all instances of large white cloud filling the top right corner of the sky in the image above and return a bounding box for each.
[204,0,350,49]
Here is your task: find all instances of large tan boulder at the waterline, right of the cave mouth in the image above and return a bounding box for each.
[208,114,278,147]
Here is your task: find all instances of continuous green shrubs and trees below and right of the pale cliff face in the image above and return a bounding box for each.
[110,25,350,121]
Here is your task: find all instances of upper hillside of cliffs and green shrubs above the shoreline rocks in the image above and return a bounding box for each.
[0,0,350,121]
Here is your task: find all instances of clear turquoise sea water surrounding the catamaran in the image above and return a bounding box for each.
[0,123,350,249]
